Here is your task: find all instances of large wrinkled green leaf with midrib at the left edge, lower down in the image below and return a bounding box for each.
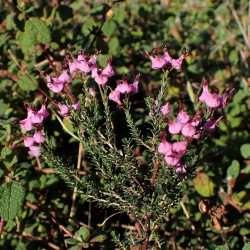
[0,181,24,221]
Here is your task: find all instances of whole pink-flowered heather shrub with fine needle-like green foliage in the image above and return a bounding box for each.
[11,46,232,249]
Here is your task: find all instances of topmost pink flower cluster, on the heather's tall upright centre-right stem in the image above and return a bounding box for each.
[146,45,188,69]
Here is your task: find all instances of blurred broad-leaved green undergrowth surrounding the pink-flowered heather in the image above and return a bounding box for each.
[0,0,250,249]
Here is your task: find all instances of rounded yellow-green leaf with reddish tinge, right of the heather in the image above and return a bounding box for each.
[193,173,215,197]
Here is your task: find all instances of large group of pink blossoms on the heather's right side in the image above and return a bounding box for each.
[158,79,234,174]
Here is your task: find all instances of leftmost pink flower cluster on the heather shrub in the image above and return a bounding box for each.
[18,99,49,157]
